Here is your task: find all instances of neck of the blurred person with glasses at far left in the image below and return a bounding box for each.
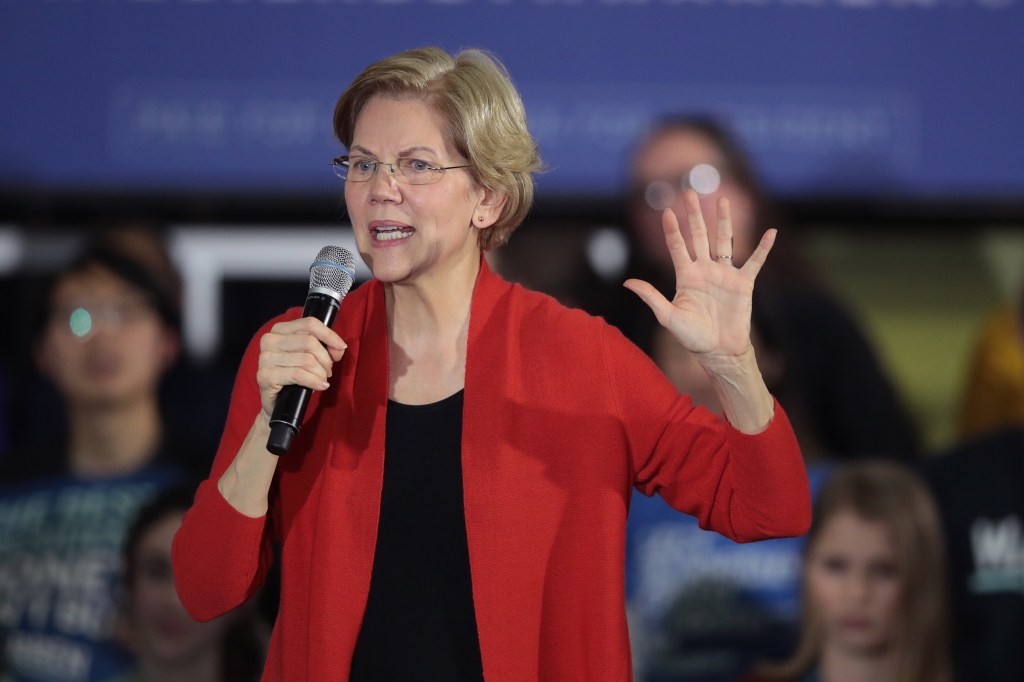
[71,396,163,477]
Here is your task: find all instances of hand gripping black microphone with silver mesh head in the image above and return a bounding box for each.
[257,246,355,455]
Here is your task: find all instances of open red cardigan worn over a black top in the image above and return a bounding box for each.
[174,261,810,682]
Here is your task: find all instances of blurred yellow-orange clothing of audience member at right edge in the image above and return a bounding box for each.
[959,292,1024,439]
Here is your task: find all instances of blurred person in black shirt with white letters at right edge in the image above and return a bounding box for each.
[923,426,1024,682]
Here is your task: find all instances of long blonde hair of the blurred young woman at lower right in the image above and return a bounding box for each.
[758,461,951,682]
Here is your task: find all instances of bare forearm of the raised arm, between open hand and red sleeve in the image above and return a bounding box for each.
[698,347,775,434]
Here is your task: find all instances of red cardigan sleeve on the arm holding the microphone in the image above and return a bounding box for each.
[172,321,284,622]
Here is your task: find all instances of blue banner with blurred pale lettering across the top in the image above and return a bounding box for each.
[0,0,1024,201]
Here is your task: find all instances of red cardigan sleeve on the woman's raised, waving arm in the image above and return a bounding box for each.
[604,328,811,542]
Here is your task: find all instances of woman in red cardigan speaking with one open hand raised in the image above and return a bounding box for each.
[173,48,810,682]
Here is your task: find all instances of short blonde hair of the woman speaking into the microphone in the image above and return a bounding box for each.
[334,47,543,251]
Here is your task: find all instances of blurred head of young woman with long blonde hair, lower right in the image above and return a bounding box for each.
[749,461,954,682]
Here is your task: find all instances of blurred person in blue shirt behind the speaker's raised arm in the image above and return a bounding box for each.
[626,310,830,682]
